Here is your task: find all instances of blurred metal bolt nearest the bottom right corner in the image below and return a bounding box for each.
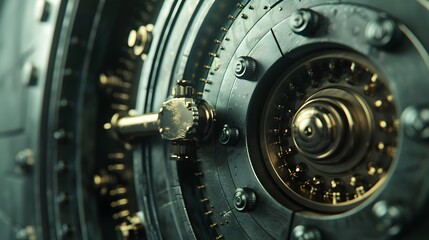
[372,201,405,236]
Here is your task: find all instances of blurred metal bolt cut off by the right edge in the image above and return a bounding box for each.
[402,106,429,141]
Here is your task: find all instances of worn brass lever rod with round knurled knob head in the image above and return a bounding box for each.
[105,80,215,160]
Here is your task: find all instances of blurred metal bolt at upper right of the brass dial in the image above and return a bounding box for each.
[365,17,399,47]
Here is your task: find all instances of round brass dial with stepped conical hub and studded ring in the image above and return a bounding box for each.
[261,52,396,212]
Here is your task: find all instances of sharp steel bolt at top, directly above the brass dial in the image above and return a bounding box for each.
[289,9,320,37]
